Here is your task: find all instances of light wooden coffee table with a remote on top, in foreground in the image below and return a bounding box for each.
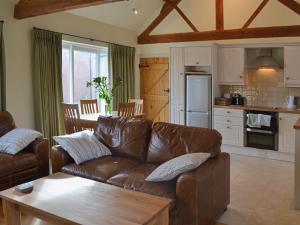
[0,173,171,225]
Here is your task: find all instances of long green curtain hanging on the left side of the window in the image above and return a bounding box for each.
[33,29,63,145]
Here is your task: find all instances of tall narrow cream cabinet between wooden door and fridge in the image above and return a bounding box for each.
[170,48,185,125]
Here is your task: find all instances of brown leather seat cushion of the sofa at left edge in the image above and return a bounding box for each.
[0,152,38,177]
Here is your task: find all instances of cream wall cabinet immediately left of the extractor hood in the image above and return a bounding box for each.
[218,47,245,85]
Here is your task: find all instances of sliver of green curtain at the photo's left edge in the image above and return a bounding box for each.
[0,22,6,111]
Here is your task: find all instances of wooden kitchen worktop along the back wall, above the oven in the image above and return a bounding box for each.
[214,105,300,114]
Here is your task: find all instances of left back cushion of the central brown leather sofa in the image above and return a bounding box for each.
[95,117,152,162]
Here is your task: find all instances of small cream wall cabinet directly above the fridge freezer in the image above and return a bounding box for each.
[184,47,212,66]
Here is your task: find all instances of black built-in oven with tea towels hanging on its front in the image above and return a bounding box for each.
[246,110,278,151]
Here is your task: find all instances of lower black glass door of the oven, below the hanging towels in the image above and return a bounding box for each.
[247,128,277,150]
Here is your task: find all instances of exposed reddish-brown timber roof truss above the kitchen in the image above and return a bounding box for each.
[138,0,300,44]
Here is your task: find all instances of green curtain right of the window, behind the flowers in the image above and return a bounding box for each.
[110,44,135,110]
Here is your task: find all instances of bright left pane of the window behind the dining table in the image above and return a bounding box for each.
[73,50,97,103]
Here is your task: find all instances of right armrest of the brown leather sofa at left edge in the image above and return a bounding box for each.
[27,138,49,177]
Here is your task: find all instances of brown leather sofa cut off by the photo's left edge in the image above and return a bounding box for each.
[0,112,49,191]
